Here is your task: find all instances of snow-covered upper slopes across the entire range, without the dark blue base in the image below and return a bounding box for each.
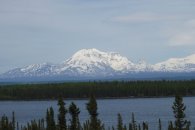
[0,49,195,78]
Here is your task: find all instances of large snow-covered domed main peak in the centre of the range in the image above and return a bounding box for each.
[56,49,142,76]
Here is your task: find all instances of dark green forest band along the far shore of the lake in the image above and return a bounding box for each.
[0,80,195,100]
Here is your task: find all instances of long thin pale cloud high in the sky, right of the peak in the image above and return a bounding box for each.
[113,12,178,22]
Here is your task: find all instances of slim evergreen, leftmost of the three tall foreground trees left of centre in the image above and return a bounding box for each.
[58,97,67,130]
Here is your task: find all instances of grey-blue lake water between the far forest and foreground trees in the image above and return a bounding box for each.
[0,97,195,130]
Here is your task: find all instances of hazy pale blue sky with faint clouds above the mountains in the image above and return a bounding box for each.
[0,0,195,73]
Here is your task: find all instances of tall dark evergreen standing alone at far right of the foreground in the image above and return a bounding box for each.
[172,95,188,130]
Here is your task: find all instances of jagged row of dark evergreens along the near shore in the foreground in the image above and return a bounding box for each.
[0,96,191,130]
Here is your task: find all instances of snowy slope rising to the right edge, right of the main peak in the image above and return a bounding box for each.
[154,54,195,72]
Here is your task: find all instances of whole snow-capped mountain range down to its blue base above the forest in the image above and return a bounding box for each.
[0,49,195,82]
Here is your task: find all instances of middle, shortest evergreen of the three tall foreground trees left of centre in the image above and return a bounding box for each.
[69,102,80,130]
